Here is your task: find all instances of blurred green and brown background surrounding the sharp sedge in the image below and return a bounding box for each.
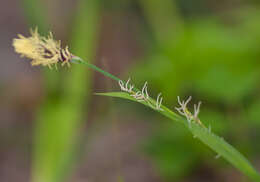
[0,0,260,182]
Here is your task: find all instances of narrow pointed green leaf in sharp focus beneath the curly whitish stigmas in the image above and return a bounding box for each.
[96,92,260,181]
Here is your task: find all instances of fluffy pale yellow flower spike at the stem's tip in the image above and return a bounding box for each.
[13,28,73,68]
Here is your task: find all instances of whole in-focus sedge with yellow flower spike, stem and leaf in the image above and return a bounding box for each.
[13,29,260,182]
